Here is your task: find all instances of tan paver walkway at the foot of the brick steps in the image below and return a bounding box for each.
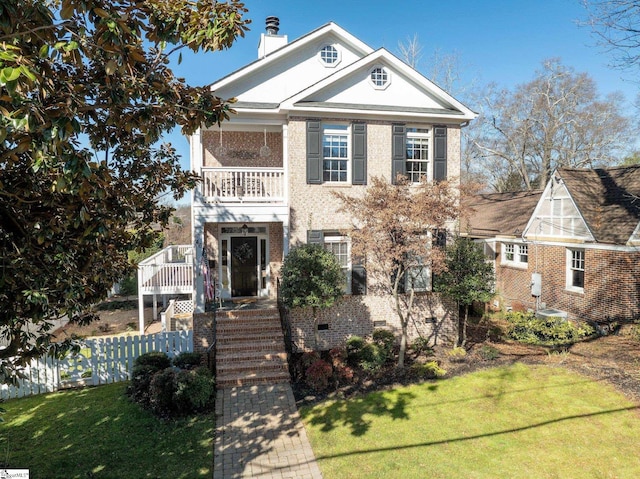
[213,383,322,479]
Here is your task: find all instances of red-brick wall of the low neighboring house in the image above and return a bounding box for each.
[496,244,640,321]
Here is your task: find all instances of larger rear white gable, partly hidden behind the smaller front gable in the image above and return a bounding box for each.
[211,23,372,104]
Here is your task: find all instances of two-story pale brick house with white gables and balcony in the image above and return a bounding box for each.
[190,17,476,348]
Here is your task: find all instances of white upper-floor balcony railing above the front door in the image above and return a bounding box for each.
[201,168,285,203]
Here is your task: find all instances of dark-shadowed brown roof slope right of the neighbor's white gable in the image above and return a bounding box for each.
[557,166,640,245]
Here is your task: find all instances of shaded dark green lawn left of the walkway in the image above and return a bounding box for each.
[0,383,214,479]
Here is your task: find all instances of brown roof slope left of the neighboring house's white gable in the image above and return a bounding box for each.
[462,190,542,238]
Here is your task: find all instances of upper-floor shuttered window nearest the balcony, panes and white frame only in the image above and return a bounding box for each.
[322,125,351,183]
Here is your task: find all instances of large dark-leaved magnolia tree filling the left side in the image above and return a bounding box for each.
[0,0,248,382]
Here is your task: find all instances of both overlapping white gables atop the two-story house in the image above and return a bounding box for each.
[210,22,477,124]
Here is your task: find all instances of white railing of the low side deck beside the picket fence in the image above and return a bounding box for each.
[138,245,193,294]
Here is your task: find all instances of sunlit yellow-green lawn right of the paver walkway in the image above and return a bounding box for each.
[301,365,640,479]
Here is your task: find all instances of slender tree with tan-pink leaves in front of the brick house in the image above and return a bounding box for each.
[336,177,458,368]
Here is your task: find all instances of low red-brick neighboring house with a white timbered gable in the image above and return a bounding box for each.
[467,166,640,324]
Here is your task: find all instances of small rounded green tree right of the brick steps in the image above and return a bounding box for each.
[280,244,345,351]
